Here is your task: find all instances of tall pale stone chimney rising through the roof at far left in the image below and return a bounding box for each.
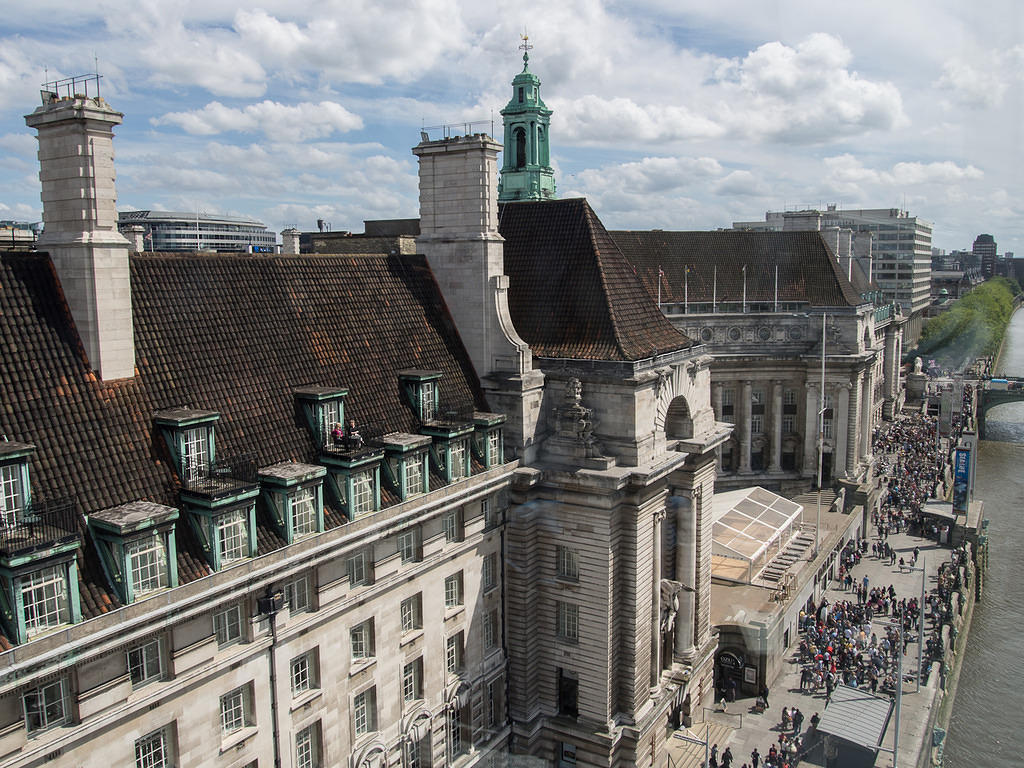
[25,85,135,381]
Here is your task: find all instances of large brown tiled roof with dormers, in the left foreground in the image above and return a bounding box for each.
[0,254,486,617]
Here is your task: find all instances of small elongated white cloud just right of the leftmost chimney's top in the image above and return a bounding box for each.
[151,100,362,141]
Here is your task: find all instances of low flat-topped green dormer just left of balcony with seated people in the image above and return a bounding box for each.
[259,462,327,544]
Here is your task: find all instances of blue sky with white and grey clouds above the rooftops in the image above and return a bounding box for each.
[0,0,1024,255]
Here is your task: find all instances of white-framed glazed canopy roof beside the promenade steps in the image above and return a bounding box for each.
[712,485,803,584]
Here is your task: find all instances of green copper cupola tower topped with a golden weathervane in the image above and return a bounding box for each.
[498,37,555,203]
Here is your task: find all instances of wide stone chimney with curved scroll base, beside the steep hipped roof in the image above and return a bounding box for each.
[413,134,544,461]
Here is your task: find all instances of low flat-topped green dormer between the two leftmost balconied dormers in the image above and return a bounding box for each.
[86,502,178,603]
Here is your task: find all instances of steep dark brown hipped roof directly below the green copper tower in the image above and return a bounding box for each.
[499,199,693,360]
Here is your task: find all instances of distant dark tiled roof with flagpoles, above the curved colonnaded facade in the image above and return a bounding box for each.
[609,230,863,307]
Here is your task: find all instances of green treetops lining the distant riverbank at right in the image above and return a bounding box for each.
[911,278,1020,369]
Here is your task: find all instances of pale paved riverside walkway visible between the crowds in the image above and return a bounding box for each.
[667,531,950,768]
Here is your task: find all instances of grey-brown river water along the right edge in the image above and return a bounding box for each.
[944,311,1024,768]
